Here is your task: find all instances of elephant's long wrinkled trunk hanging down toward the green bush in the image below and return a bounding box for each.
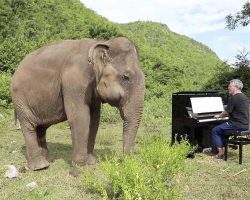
[121,77,144,154]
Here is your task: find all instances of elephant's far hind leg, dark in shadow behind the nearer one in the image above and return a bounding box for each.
[37,126,54,163]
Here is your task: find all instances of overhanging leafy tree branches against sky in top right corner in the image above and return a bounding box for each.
[226,1,250,30]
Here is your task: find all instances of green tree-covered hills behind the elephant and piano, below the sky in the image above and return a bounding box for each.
[0,0,250,123]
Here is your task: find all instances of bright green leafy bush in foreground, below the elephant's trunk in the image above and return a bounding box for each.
[84,136,191,199]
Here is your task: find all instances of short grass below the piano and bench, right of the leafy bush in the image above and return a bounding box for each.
[183,149,250,200]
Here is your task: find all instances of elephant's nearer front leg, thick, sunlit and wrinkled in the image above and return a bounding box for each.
[65,99,90,165]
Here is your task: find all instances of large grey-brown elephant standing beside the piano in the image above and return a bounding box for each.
[11,37,145,170]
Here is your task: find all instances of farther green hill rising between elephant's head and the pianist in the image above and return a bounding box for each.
[120,22,227,97]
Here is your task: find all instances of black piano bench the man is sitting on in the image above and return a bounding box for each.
[224,129,250,164]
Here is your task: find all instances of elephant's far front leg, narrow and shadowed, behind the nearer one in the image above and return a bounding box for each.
[88,102,101,164]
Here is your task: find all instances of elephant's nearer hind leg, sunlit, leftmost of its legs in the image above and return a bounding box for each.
[21,122,49,170]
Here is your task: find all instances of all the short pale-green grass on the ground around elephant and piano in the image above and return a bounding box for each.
[0,115,250,200]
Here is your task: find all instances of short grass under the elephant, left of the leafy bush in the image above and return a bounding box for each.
[0,121,91,199]
